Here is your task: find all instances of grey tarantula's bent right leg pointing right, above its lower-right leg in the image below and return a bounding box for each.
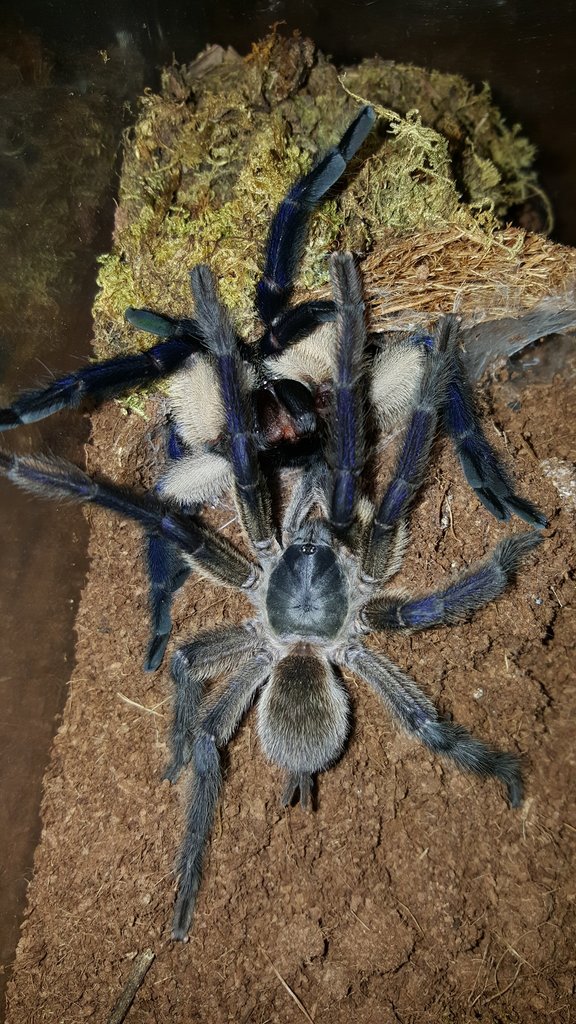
[362,530,542,630]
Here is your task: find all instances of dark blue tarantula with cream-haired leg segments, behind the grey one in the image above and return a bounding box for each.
[0,106,545,671]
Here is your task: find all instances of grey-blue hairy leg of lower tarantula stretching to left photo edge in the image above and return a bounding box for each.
[0,452,257,588]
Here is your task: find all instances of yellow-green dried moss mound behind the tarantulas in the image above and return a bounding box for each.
[96,33,557,357]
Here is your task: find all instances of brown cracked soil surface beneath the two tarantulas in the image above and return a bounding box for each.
[7,348,576,1024]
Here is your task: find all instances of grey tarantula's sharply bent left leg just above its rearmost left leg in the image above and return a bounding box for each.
[164,625,261,782]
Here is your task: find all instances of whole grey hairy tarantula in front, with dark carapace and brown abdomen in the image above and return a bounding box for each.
[0,254,540,939]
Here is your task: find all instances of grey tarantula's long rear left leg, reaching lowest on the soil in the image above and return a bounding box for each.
[172,653,271,941]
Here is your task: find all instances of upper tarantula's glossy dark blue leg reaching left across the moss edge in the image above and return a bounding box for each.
[0,335,200,430]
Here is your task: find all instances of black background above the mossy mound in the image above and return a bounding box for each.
[11,0,576,244]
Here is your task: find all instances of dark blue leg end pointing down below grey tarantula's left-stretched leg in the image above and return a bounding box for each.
[145,534,191,672]
